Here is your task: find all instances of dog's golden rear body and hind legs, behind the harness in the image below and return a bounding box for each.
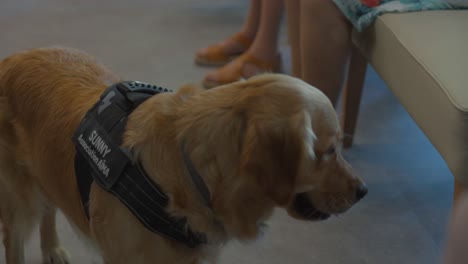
[0,48,117,264]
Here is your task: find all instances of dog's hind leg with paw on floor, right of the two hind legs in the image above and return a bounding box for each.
[41,208,70,264]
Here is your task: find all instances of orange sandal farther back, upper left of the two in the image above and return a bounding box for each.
[195,32,252,67]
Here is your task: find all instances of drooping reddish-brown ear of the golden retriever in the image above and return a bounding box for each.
[241,112,304,206]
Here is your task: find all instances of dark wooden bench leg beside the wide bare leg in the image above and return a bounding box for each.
[342,45,367,148]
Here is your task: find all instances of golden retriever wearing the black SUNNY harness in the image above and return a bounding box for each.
[0,48,367,264]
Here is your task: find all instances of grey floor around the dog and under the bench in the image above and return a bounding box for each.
[0,0,453,264]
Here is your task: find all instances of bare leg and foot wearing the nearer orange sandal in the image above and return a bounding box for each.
[204,0,284,86]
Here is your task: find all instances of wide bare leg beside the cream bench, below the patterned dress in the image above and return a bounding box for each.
[300,0,351,105]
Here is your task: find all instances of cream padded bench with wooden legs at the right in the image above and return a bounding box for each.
[342,10,468,204]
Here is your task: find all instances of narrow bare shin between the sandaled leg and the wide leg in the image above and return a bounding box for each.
[286,0,302,78]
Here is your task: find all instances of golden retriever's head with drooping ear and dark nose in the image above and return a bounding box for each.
[234,75,367,220]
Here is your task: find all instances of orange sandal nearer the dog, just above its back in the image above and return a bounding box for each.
[203,52,281,89]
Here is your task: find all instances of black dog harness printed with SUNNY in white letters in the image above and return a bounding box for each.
[73,82,210,248]
